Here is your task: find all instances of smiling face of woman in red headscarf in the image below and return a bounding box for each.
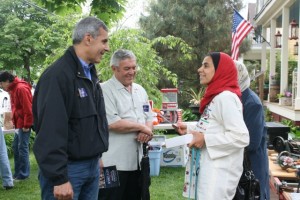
[198,56,215,85]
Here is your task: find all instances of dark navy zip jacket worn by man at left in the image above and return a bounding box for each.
[33,47,108,185]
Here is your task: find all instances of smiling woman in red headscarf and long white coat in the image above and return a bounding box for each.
[176,52,249,200]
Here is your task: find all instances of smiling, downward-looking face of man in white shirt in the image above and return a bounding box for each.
[112,58,137,87]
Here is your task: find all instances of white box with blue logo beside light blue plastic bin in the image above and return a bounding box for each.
[160,145,189,167]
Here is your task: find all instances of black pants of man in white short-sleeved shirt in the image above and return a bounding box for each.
[98,170,141,200]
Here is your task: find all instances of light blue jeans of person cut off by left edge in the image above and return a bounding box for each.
[0,127,14,186]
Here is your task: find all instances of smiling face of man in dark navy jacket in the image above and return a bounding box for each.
[85,28,109,63]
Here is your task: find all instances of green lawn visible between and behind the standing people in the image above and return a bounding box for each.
[0,153,185,200]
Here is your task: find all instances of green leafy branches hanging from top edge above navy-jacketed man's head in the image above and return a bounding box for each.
[35,0,127,25]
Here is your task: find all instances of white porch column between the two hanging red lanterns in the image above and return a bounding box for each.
[280,7,290,104]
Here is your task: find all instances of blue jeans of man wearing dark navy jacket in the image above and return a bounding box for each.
[39,158,100,200]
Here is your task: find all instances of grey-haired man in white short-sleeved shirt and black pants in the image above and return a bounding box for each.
[98,49,153,200]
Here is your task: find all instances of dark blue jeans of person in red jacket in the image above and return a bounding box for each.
[13,128,31,179]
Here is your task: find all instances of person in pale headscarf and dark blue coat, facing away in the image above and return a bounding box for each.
[234,61,270,200]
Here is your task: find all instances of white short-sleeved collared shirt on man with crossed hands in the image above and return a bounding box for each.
[101,76,153,171]
